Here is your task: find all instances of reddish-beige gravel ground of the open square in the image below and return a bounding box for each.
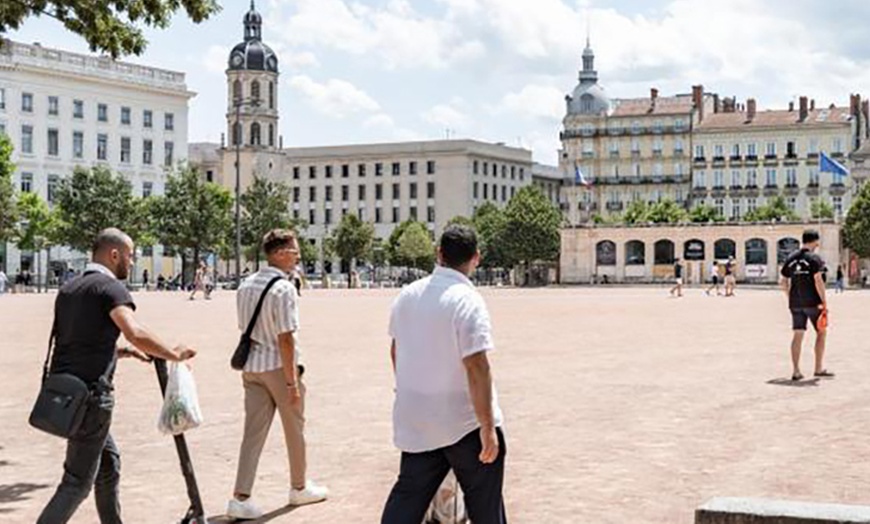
[0,288,870,524]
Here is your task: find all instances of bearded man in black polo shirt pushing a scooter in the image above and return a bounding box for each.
[37,229,196,524]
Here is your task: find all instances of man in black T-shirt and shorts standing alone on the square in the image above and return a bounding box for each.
[782,229,834,381]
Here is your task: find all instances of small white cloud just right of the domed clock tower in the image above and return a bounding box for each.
[289,75,381,118]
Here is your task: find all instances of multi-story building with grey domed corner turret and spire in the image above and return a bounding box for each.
[559,38,717,224]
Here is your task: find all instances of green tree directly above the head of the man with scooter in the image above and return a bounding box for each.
[55,166,148,253]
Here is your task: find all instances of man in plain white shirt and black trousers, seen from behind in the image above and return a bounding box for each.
[381,225,507,524]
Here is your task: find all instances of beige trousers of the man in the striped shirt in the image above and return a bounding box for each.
[235,369,306,495]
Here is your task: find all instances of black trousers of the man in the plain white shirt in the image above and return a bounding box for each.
[381,428,507,524]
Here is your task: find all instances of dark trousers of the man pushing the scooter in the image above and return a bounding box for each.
[37,393,121,524]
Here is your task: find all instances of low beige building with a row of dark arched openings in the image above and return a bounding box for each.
[560,223,845,284]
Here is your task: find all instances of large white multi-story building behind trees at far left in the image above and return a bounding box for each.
[0,41,193,273]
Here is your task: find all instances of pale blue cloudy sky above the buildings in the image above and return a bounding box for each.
[8,0,870,163]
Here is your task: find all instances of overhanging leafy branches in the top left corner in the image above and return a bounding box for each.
[0,0,220,58]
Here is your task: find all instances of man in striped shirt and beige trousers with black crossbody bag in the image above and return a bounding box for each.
[227,229,328,519]
